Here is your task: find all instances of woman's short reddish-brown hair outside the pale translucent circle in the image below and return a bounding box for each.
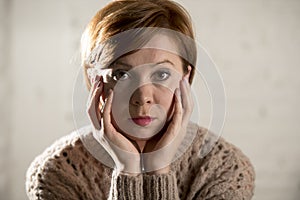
[81,0,197,89]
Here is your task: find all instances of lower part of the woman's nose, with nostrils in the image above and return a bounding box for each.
[130,85,153,106]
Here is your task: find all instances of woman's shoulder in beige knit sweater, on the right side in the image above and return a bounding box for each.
[180,122,255,199]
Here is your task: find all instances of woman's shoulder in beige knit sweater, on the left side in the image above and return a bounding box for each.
[26,126,111,199]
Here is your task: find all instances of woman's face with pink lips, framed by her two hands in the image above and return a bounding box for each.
[105,35,188,140]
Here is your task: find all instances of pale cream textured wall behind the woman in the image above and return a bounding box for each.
[0,0,300,200]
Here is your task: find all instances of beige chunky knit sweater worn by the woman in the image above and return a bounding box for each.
[26,124,255,200]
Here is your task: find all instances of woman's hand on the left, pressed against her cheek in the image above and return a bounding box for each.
[87,75,141,174]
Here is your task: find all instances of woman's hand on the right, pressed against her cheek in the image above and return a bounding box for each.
[143,72,194,174]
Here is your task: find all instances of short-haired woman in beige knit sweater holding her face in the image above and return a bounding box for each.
[26,0,254,200]
